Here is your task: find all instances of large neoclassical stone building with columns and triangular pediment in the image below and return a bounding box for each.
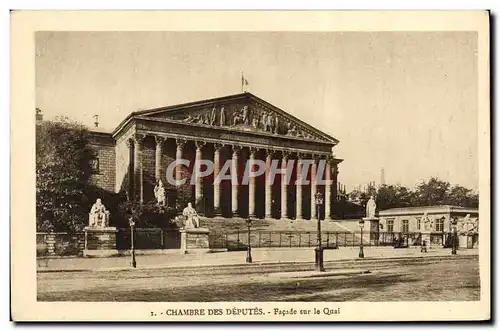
[88,92,342,219]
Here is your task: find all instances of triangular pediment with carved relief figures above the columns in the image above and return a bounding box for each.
[135,93,338,144]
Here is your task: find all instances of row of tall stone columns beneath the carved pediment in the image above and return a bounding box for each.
[128,134,337,219]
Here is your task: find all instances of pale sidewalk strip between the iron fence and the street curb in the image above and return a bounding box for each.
[37,247,478,272]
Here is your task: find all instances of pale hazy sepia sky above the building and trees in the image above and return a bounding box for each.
[35,32,478,190]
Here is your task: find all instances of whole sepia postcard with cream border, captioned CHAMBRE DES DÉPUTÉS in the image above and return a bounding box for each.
[11,11,490,321]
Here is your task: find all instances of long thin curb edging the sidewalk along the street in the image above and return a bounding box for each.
[37,254,479,273]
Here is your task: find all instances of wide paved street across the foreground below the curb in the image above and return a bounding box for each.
[37,255,480,301]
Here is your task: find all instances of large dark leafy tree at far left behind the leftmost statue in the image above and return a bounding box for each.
[36,118,95,232]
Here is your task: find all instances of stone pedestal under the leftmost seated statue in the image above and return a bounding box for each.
[83,227,118,257]
